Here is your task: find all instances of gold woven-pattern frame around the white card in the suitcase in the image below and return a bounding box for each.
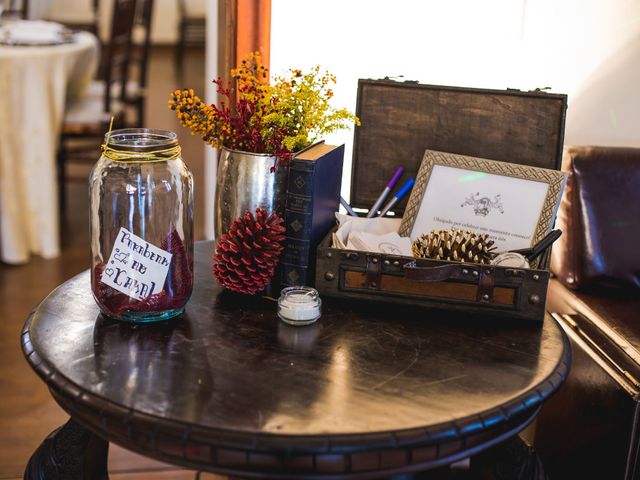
[398,150,567,245]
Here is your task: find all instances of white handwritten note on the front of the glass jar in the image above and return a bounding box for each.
[101,227,172,300]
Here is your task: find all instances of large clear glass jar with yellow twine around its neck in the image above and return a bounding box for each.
[89,128,193,322]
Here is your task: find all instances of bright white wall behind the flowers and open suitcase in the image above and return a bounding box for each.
[271,0,640,176]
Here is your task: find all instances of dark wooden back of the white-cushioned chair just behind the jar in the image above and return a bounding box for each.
[104,0,136,112]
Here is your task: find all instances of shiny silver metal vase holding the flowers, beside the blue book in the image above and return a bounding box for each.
[214,147,289,238]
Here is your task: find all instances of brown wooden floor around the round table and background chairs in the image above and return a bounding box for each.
[0,49,221,480]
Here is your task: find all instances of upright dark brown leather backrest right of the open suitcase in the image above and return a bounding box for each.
[551,147,640,288]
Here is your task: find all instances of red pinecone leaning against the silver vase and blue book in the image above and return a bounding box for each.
[213,208,285,295]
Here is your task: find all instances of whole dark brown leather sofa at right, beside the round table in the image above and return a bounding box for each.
[534,147,640,480]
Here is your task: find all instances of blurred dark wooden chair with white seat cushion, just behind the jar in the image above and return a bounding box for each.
[58,0,136,210]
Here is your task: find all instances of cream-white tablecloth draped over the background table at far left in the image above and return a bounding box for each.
[0,32,98,264]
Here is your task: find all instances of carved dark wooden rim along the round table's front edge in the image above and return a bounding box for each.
[21,310,571,478]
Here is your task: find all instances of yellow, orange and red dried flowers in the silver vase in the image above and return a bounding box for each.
[169,52,359,167]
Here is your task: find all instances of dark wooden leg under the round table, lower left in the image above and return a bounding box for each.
[24,419,109,480]
